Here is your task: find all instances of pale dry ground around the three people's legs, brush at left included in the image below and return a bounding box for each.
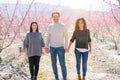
[0,40,120,80]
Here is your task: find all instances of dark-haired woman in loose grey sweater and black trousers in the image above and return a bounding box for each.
[23,22,44,80]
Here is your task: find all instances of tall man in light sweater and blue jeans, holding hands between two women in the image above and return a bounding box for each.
[45,12,68,80]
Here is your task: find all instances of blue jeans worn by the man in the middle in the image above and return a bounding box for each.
[50,47,67,80]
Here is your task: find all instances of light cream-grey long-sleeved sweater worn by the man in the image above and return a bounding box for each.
[45,23,68,48]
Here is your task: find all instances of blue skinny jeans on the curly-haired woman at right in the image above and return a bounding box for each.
[75,49,88,76]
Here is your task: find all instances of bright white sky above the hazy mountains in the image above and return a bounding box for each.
[0,0,118,11]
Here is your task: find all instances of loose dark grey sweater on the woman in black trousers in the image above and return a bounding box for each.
[23,32,44,57]
